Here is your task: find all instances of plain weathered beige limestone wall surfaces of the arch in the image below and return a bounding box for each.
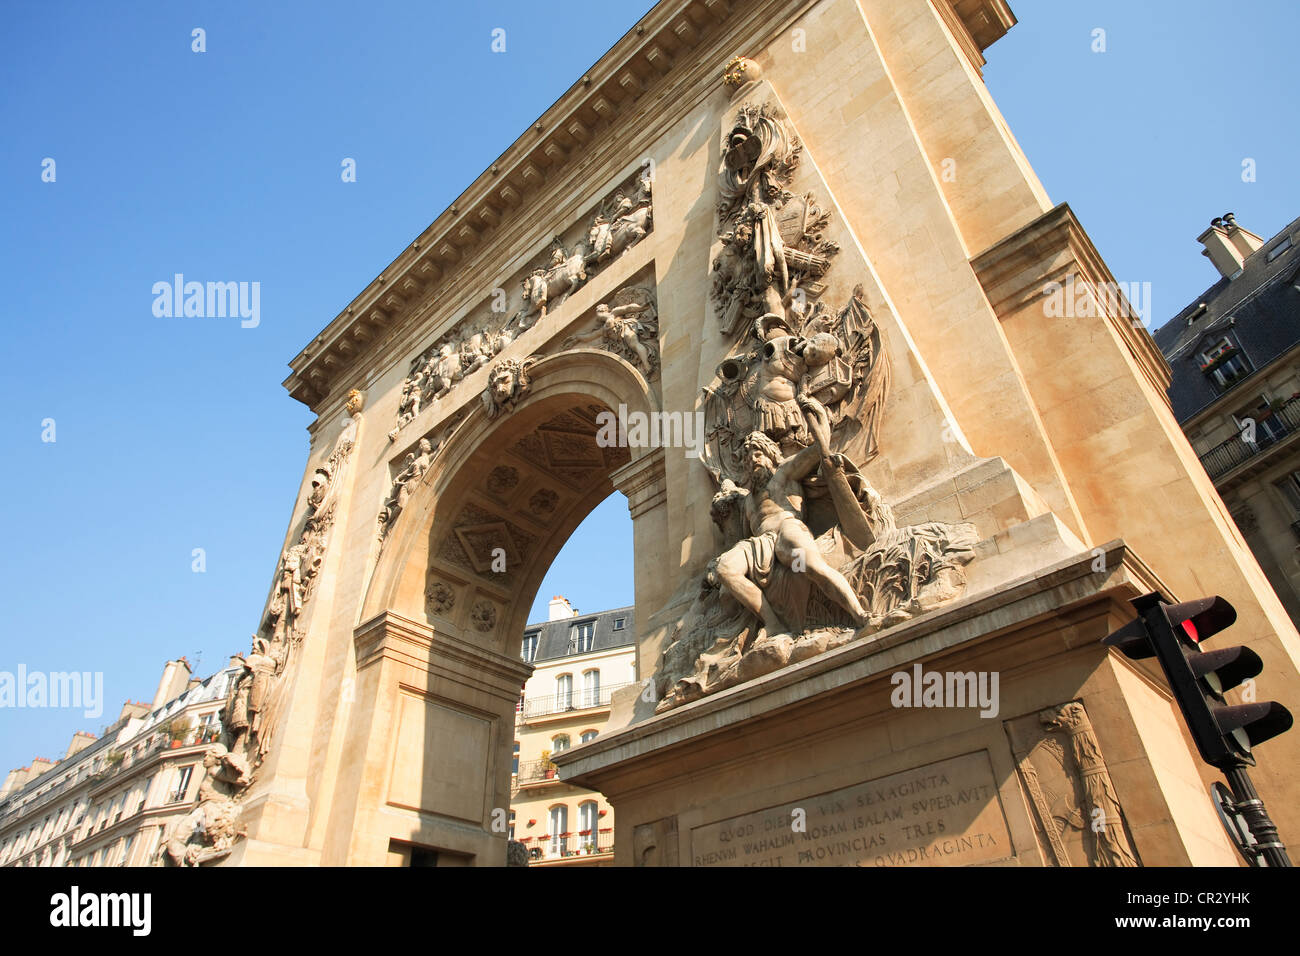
[231,0,1300,864]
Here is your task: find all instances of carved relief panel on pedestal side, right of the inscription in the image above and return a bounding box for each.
[1006,701,1140,866]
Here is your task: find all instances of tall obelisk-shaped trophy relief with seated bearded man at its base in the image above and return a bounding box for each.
[655,104,978,711]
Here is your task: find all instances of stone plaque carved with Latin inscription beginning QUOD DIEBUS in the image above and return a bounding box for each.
[690,750,1011,866]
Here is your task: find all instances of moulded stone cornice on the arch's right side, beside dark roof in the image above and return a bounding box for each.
[971,203,1171,406]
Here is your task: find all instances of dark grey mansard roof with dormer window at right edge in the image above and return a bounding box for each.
[1154,219,1300,423]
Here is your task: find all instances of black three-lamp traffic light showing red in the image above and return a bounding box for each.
[1102,593,1292,771]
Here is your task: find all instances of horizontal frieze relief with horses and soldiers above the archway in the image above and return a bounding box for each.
[389,173,658,441]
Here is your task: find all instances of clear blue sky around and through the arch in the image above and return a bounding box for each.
[0,0,1300,773]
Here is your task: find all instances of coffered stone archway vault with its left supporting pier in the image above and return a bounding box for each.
[322,349,664,865]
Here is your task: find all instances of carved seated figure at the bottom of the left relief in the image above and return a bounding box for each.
[159,744,250,866]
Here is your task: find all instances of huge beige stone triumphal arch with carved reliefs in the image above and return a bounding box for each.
[186,0,1300,866]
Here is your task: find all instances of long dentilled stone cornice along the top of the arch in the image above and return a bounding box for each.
[283,0,1015,418]
